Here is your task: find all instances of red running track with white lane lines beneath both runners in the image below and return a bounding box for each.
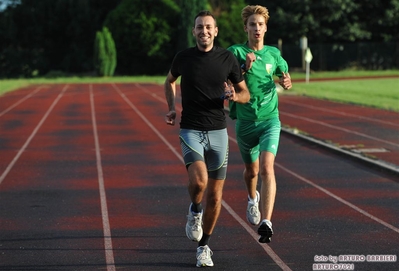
[0,84,399,271]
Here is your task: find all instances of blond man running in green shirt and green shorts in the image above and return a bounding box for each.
[228,5,292,243]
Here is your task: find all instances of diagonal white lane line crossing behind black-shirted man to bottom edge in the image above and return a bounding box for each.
[112,84,291,271]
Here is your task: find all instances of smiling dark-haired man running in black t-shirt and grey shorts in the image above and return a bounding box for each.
[165,11,249,267]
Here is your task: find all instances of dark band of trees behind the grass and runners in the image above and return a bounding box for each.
[0,0,399,79]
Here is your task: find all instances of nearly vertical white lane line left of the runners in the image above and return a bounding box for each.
[90,85,115,271]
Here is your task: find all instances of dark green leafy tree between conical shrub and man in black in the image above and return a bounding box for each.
[104,0,180,74]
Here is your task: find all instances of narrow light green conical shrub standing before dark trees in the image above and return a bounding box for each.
[94,27,117,76]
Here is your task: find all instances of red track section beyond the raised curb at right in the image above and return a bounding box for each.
[279,95,399,173]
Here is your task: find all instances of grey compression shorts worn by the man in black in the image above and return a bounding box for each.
[179,129,229,180]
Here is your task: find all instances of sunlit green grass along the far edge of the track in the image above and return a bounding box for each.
[0,70,399,112]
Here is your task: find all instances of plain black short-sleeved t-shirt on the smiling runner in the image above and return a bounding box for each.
[171,46,244,131]
